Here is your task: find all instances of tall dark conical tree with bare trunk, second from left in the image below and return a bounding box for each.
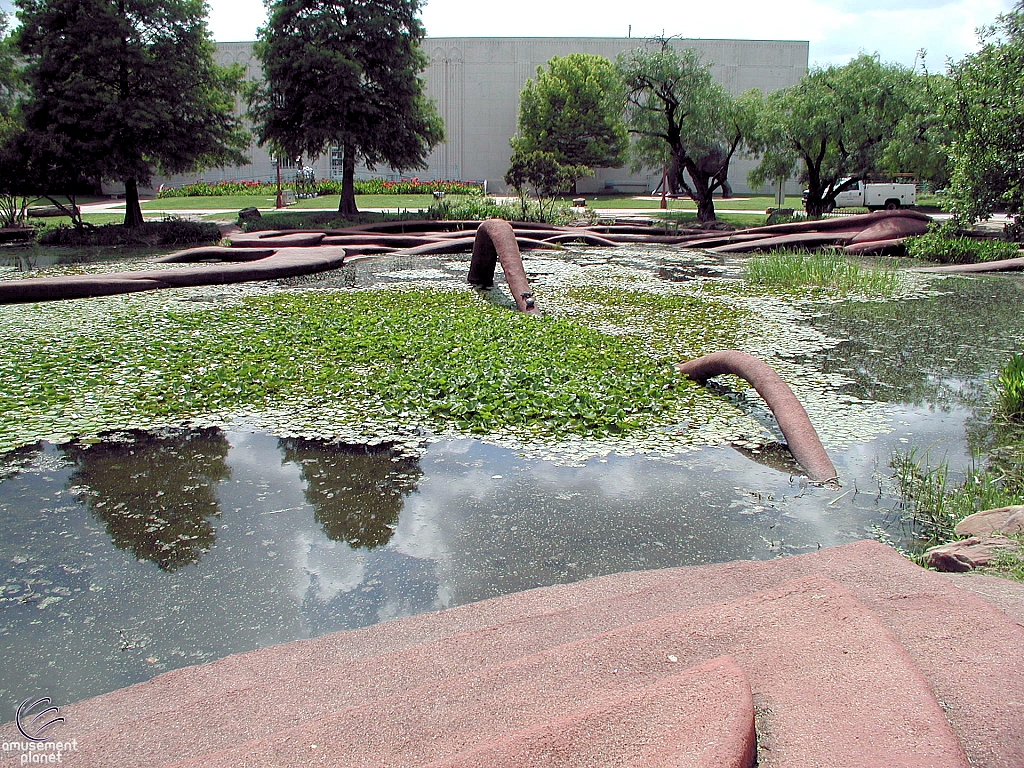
[250,0,444,214]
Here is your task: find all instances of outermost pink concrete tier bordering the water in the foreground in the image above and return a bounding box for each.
[0,542,1024,768]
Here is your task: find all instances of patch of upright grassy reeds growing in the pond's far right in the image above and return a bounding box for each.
[743,251,900,298]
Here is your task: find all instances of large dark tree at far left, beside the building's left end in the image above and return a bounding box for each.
[16,0,249,226]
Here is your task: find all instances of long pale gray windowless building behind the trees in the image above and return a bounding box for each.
[154,37,809,194]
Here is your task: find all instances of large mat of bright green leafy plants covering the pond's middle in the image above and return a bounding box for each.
[0,289,733,450]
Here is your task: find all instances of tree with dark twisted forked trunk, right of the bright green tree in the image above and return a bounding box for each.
[616,38,754,222]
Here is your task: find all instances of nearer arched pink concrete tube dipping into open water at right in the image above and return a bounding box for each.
[676,349,837,482]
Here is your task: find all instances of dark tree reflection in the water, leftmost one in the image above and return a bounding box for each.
[62,429,229,570]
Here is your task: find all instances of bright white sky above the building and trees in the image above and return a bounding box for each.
[201,0,1014,72]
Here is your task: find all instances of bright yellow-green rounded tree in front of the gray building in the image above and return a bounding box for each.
[512,53,629,186]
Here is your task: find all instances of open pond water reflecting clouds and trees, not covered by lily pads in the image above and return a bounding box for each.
[0,250,1024,720]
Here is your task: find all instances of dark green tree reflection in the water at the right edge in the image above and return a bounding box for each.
[812,278,1024,409]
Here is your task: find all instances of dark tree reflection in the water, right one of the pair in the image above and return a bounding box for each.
[278,437,422,549]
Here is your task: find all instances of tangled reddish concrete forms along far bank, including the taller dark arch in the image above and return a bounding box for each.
[0,211,937,311]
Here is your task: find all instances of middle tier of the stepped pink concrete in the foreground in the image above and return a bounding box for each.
[155,577,968,768]
